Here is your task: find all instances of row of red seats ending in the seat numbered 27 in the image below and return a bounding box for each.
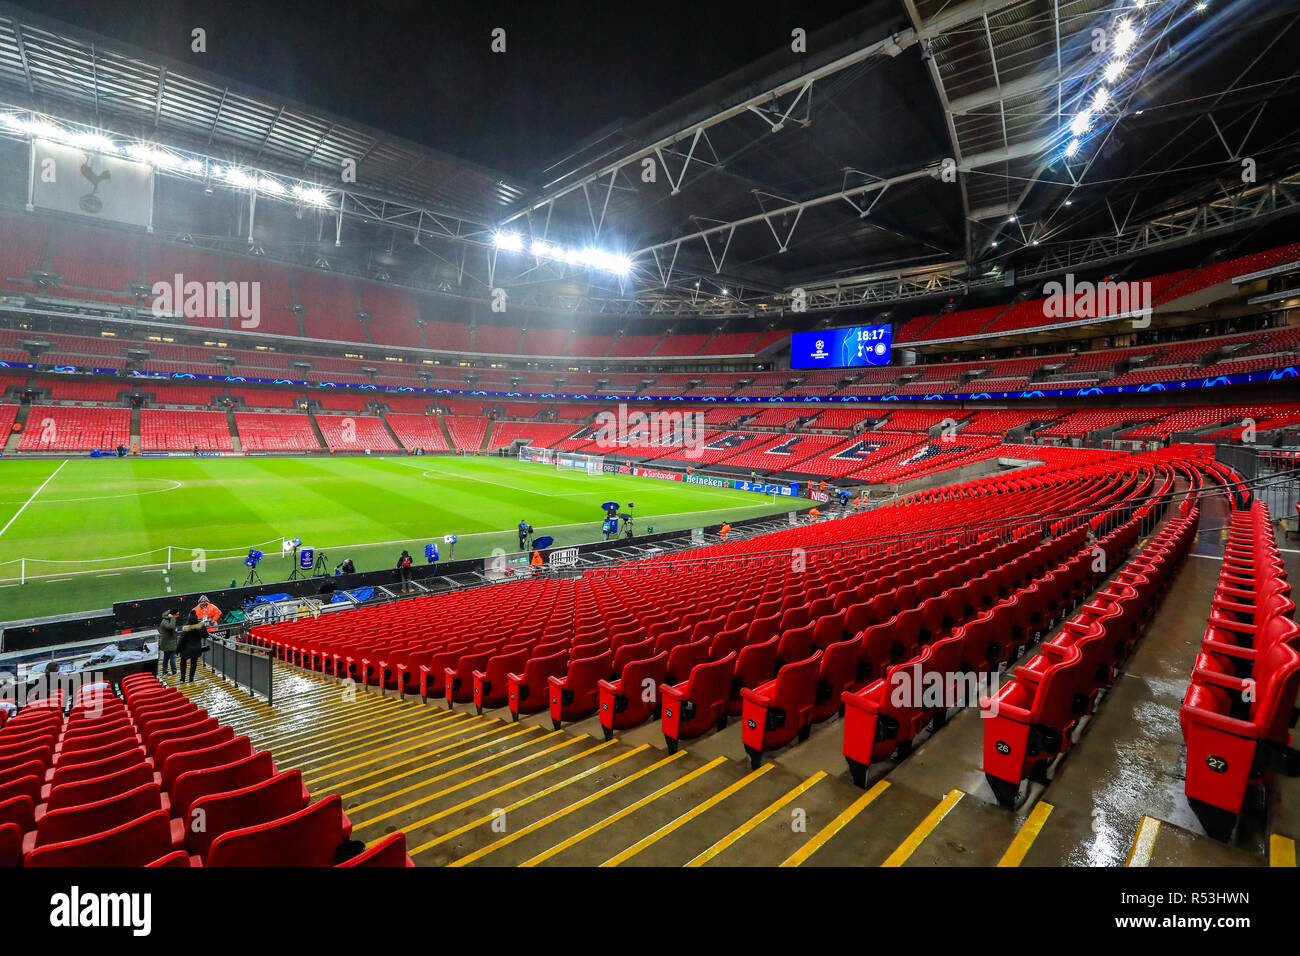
[1178,501,1300,839]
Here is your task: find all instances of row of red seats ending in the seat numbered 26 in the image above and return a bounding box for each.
[980,476,1200,806]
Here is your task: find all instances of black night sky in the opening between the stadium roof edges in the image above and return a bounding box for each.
[30,0,862,176]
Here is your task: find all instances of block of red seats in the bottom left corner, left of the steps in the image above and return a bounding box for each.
[0,674,410,866]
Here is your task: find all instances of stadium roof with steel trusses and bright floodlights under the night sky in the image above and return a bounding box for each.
[0,0,1300,317]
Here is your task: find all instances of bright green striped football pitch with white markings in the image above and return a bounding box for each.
[0,457,793,622]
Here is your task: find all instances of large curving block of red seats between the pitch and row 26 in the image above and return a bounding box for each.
[254,451,1201,780]
